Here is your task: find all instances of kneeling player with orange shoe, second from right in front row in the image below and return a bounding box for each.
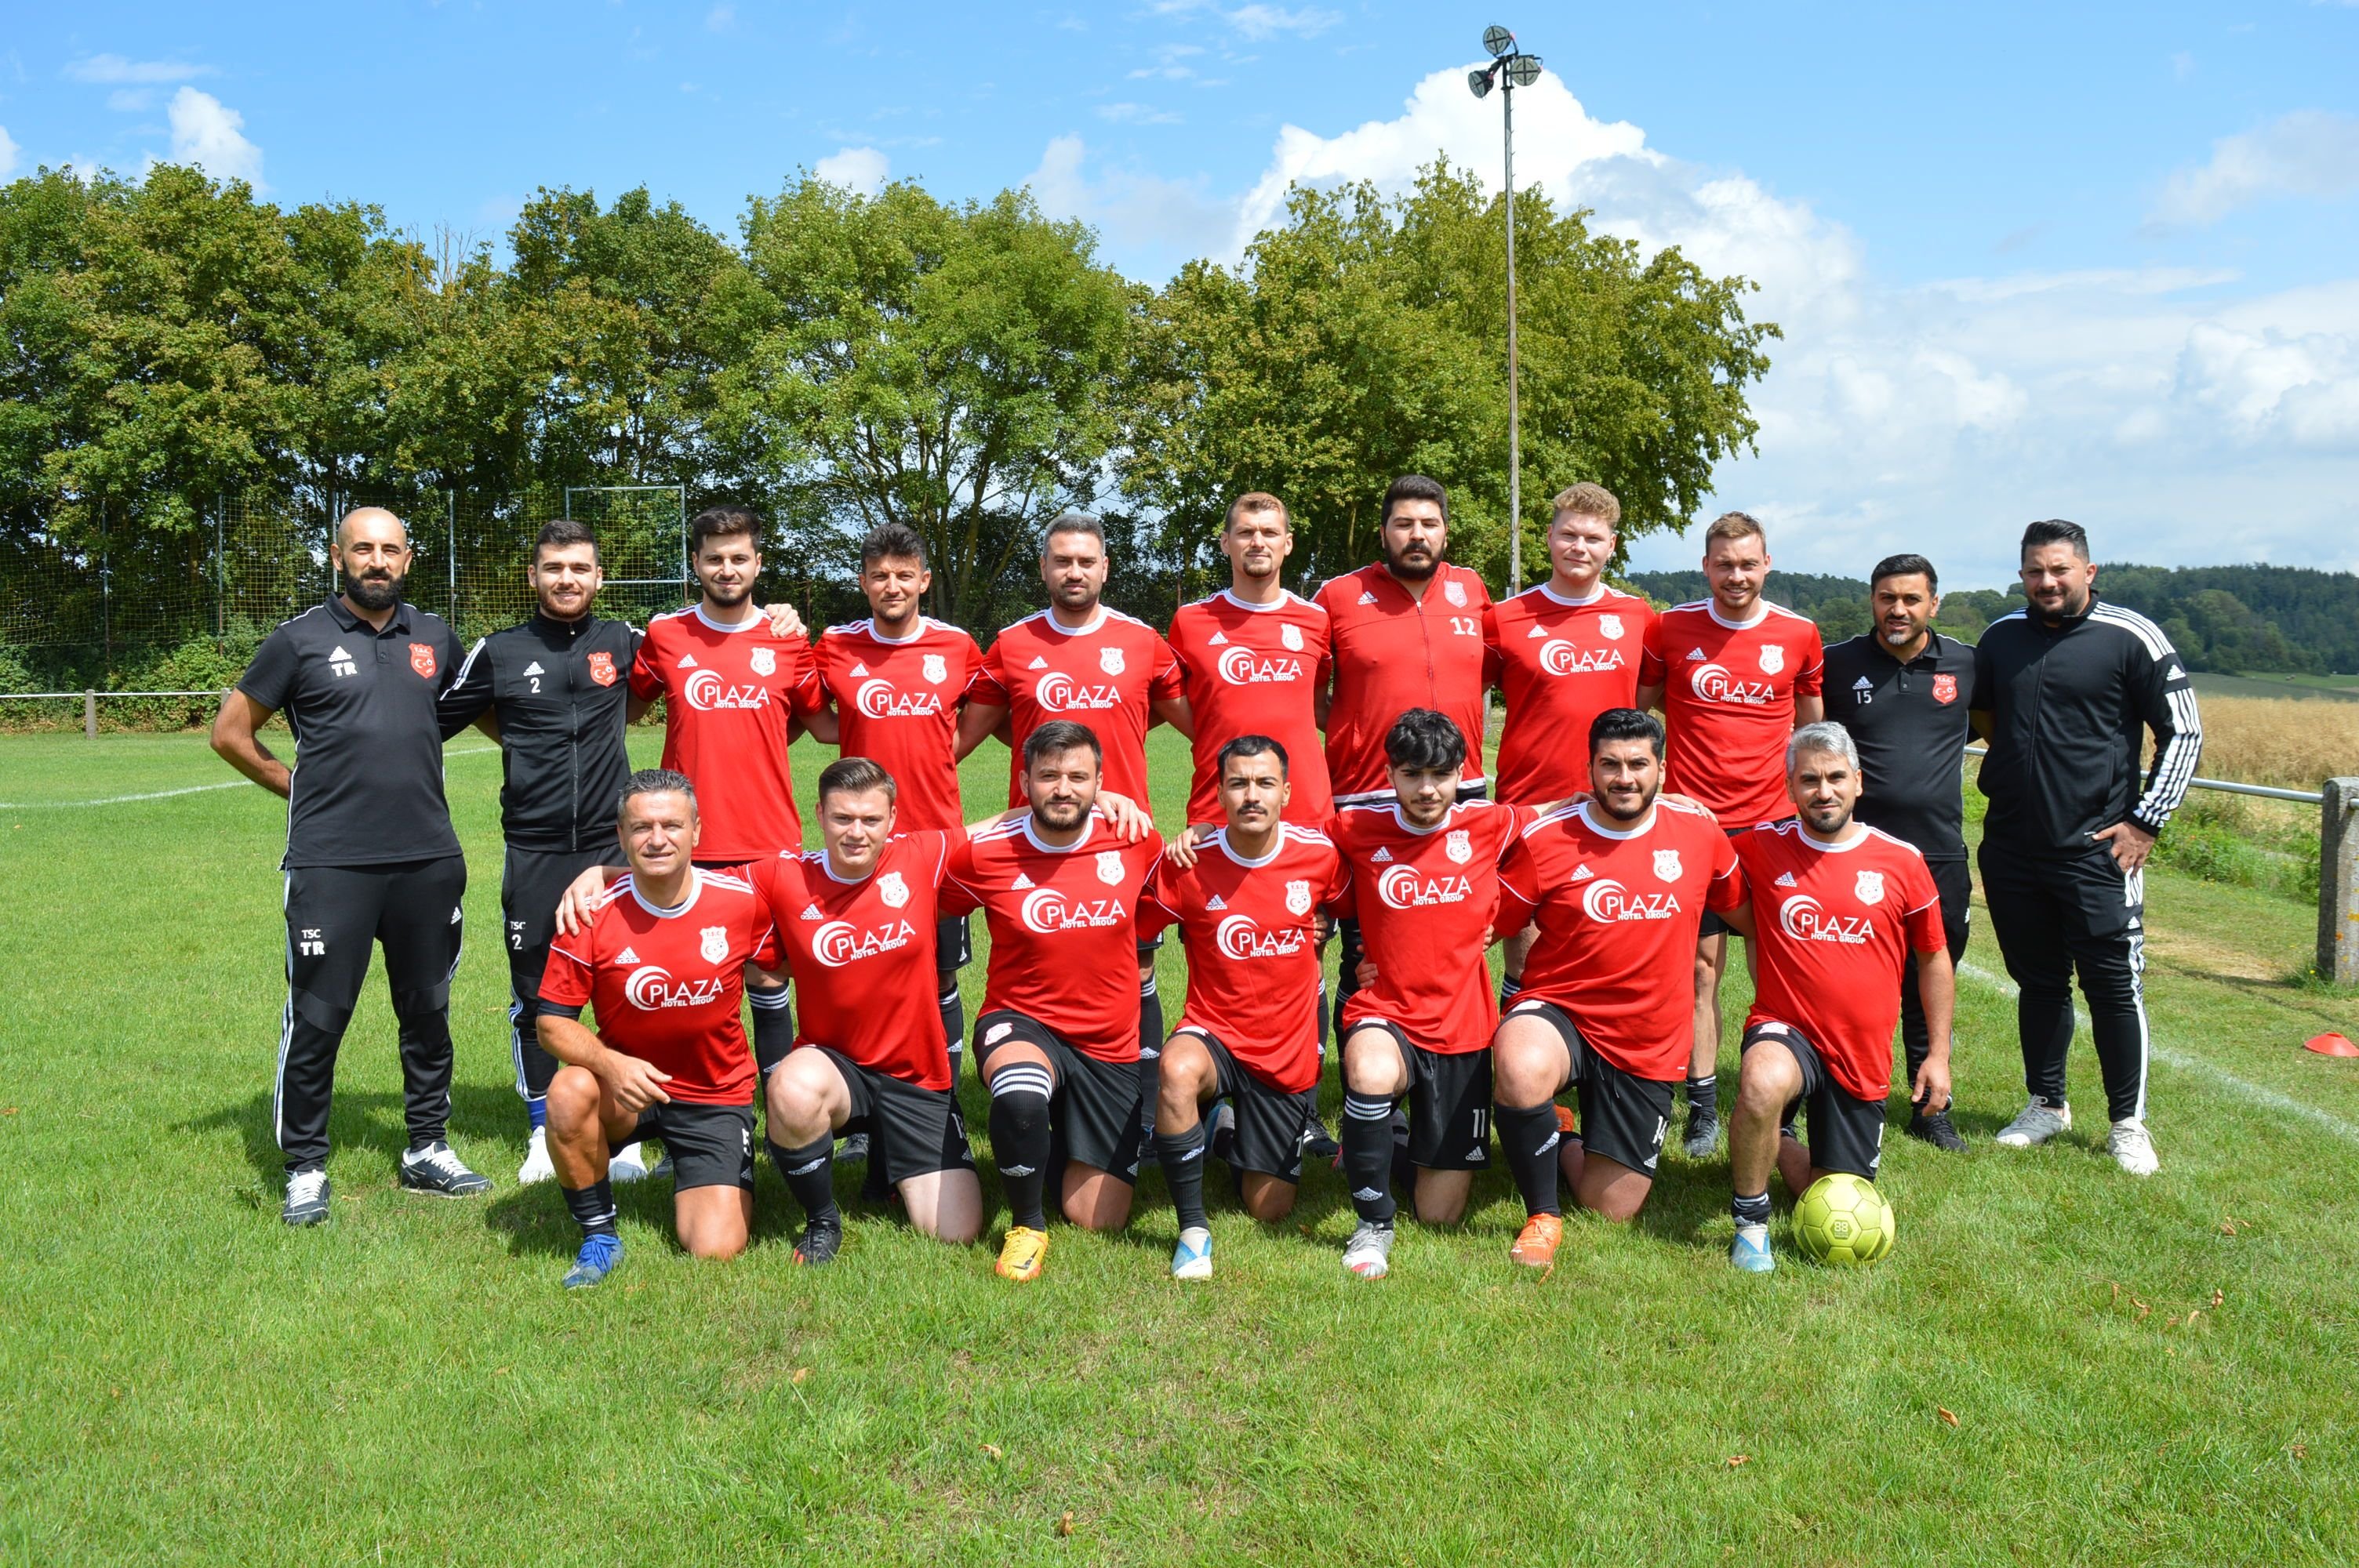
[1493,707,1746,1269]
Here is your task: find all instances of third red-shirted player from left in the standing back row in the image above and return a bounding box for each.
[958,512,1196,1089]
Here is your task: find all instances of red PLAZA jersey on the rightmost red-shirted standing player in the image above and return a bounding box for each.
[1637,599,1826,830]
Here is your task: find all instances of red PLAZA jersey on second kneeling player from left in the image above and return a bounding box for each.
[753,833,951,1089]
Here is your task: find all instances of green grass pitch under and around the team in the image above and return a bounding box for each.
[0,731,2359,1563]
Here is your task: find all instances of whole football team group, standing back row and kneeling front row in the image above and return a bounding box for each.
[213,474,2203,1290]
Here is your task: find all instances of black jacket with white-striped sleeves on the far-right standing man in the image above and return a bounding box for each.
[1975,594,2203,856]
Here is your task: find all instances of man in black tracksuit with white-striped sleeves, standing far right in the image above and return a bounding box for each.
[1972,521,2203,1177]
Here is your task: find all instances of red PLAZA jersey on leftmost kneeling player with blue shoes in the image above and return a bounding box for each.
[540,870,778,1106]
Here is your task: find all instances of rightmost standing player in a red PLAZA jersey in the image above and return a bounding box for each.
[1635,512,1826,1160]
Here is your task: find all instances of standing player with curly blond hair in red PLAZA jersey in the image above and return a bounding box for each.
[1481,484,1654,1007]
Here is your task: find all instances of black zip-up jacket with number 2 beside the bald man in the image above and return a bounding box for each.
[436,615,639,851]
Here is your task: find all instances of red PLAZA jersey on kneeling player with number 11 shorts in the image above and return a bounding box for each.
[1329,800,1536,1056]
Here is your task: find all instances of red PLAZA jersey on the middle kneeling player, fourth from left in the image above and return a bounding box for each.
[1140,823,1352,1094]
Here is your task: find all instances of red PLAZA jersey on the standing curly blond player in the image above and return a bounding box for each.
[1481,583,1654,807]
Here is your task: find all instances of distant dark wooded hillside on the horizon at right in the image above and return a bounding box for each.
[1628,564,2359,674]
